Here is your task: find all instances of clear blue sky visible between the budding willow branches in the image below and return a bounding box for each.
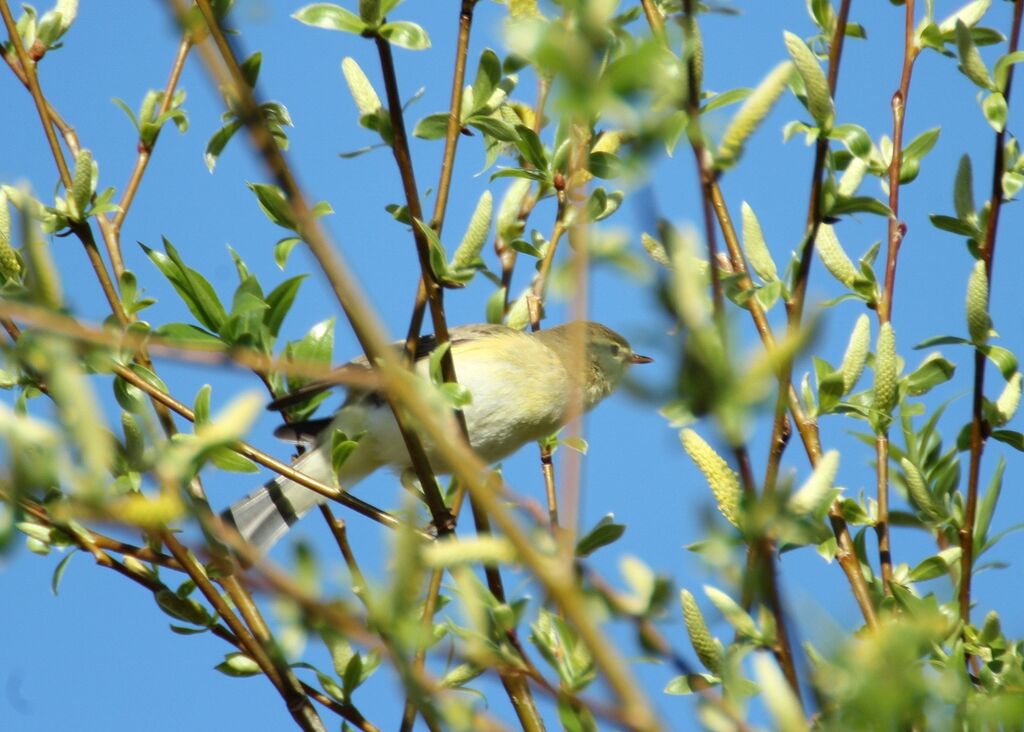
[0,0,1024,732]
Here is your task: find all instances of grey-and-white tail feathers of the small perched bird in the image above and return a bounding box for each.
[221,446,370,554]
